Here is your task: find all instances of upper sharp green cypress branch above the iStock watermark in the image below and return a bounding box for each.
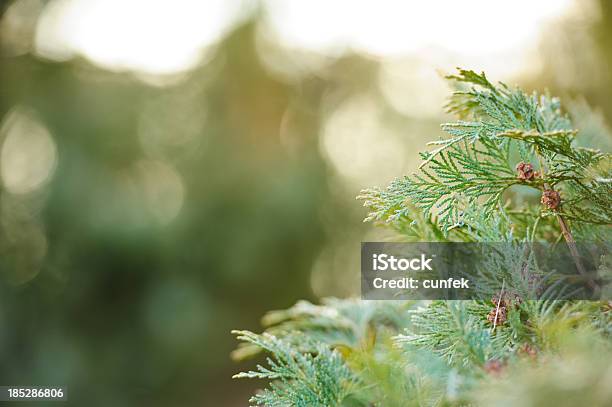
[358,70,612,234]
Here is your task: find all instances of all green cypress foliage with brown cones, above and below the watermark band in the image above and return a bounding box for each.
[233,69,612,406]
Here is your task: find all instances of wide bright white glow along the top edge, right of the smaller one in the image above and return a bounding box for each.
[265,0,571,56]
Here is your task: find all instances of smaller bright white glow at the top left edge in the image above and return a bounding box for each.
[36,0,251,75]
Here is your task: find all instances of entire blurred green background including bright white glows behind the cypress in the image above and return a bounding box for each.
[0,0,612,407]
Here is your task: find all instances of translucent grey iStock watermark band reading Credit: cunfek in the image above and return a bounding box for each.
[361,242,612,300]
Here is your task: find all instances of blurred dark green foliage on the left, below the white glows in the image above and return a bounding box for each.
[0,16,342,406]
